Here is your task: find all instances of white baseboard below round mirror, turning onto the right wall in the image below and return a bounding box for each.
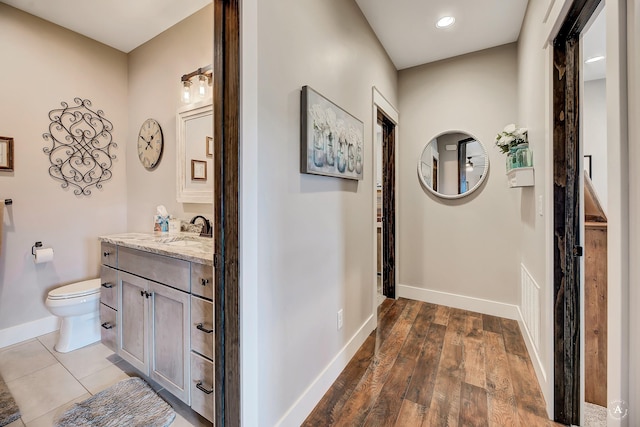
[396,285,548,410]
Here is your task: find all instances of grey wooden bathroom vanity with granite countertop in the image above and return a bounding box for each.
[100,233,214,421]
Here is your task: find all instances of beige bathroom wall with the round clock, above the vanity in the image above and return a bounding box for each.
[122,5,213,231]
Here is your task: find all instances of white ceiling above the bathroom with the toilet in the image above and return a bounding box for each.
[2,0,212,53]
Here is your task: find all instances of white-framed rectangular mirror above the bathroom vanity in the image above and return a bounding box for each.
[176,100,213,203]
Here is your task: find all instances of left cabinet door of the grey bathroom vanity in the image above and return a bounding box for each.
[118,271,149,375]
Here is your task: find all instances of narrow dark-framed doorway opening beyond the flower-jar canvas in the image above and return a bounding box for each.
[375,109,396,303]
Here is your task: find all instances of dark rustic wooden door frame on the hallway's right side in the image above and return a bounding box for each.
[553,0,601,425]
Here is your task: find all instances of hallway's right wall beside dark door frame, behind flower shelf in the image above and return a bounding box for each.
[518,2,560,408]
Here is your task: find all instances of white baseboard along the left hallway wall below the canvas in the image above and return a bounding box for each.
[276,315,377,427]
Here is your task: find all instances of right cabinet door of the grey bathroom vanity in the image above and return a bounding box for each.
[149,282,190,404]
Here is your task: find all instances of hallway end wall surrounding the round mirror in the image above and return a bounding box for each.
[397,44,521,304]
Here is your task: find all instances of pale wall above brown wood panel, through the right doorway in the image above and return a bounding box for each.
[582,79,609,212]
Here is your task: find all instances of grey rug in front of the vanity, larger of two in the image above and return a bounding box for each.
[54,378,176,427]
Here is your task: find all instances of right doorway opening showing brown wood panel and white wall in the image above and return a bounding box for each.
[580,2,609,422]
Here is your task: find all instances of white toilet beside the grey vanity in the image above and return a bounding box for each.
[45,279,100,353]
